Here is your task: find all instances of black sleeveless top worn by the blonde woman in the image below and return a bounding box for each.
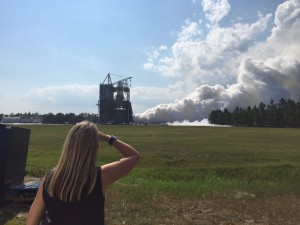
[43,167,105,225]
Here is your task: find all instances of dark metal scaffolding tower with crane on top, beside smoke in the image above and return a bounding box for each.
[97,73,133,124]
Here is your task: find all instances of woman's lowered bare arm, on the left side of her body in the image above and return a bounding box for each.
[26,181,45,225]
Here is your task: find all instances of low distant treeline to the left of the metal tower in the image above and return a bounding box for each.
[0,112,98,124]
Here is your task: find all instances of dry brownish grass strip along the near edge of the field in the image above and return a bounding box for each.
[0,191,300,225]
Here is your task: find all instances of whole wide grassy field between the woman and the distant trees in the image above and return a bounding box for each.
[0,125,300,225]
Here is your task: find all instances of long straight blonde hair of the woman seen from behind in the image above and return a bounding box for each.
[46,121,99,202]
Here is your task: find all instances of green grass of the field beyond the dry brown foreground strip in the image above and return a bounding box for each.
[2,125,300,224]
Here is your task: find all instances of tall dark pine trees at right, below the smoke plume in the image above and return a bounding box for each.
[208,98,300,127]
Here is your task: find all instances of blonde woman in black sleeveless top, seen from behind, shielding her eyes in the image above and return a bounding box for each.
[26,121,140,225]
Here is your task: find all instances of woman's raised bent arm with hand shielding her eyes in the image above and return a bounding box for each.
[99,132,140,195]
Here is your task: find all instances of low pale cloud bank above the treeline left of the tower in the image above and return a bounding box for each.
[0,84,99,114]
